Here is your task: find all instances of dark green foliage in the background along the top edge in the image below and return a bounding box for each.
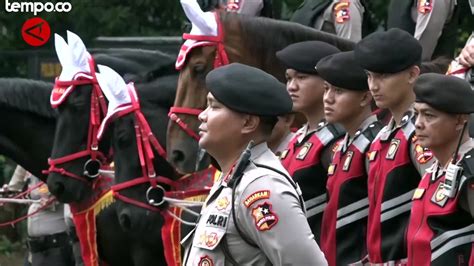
[0,0,474,77]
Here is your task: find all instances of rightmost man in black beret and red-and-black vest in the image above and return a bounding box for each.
[407,73,474,266]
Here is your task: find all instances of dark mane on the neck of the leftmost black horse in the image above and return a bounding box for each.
[0,78,57,119]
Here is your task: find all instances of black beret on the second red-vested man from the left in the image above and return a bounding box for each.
[316,51,369,91]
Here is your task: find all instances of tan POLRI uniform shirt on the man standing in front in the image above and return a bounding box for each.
[182,143,327,265]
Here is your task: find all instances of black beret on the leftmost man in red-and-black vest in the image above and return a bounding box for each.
[276,41,340,74]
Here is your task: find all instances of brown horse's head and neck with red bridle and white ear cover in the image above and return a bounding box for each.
[167,6,354,173]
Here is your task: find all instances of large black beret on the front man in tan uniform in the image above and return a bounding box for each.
[206,63,293,116]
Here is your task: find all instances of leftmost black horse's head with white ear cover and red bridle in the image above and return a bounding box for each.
[48,31,107,202]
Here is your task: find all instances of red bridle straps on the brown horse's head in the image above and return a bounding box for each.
[168,12,229,141]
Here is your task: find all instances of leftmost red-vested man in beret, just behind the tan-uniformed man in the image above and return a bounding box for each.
[276,41,344,243]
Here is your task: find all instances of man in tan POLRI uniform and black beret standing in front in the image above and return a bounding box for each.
[183,63,326,265]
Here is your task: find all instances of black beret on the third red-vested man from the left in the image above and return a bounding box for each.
[354,28,422,73]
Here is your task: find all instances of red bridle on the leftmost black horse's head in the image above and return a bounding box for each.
[43,57,107,183]
